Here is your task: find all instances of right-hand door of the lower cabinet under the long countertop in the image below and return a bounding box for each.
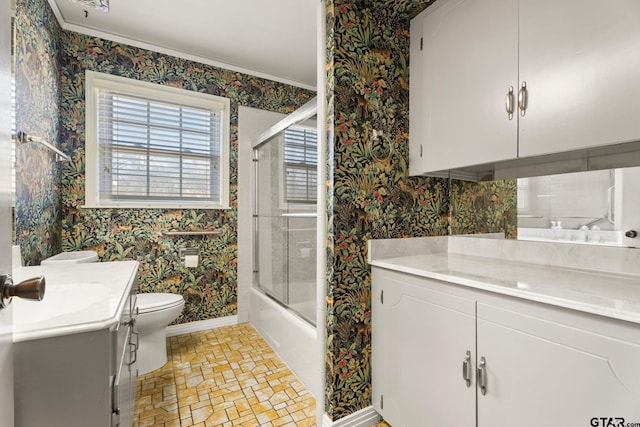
[477,302,640,427]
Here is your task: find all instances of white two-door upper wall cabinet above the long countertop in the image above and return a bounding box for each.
[410,0,640,177]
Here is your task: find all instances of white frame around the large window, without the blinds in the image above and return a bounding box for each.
[82,70,231,209]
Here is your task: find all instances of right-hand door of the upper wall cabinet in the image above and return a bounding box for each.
[519,0,640,157]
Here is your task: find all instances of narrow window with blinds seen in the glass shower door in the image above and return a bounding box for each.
[284,127,318,205]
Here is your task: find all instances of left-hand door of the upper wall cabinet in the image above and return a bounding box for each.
[410,0,518,172]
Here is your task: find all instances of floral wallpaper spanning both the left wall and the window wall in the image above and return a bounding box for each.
[16,0,315,323]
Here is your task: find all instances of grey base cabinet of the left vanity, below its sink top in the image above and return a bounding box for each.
[14,288,137,427]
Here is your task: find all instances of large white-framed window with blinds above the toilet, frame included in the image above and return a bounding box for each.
[85,71,229,208]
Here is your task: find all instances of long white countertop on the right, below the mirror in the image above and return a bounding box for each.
[369,237,640,323]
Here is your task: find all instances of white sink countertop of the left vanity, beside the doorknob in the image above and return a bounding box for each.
[12,261,138,342]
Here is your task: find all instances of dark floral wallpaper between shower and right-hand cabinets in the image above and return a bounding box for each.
[325,0,516,421]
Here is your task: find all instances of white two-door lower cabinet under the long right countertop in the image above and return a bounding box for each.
[372,267,640,427]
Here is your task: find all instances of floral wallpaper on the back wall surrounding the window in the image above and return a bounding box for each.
[60,32,315,323]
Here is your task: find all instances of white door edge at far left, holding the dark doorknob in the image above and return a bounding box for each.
[0,0,13,427]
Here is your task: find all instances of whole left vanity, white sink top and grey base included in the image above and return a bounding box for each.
[13,261,138,427]
